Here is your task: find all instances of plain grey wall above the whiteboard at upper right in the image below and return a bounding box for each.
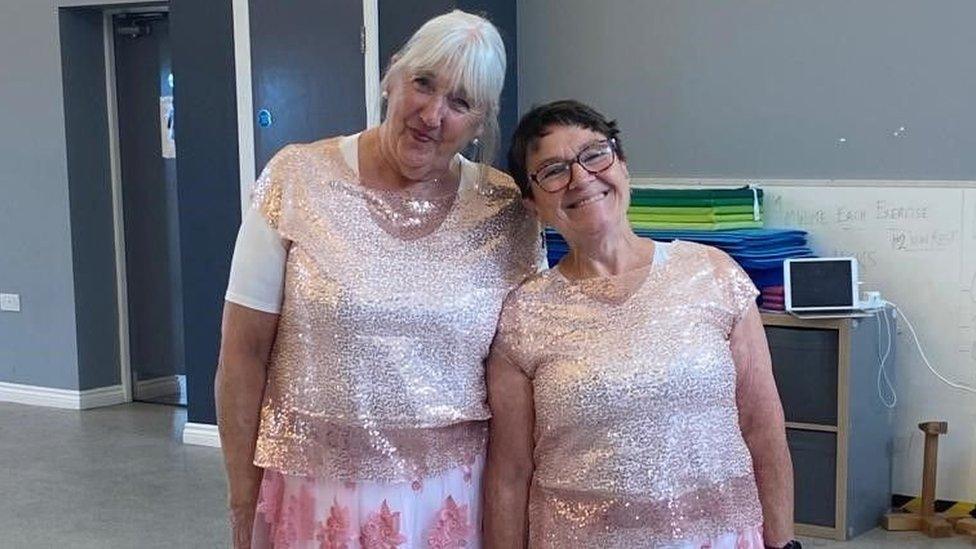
[518,0,976,179]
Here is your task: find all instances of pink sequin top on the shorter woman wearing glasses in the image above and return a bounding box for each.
[492,242,762,548]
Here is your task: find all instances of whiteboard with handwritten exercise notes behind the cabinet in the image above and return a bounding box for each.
[765,182,976,502]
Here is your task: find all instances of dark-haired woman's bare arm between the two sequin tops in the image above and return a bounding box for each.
[484,353,535,549]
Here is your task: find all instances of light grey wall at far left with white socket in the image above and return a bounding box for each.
[0,0,79,389]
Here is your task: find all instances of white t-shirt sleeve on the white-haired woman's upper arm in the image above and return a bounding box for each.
[224,208,288,314]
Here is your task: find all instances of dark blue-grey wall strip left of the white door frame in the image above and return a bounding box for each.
[59,8,121,389]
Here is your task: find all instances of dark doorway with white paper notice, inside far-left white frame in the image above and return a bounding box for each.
[112,9,186,406]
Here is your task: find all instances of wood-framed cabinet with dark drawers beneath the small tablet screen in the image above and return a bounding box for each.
[763,313,894,540]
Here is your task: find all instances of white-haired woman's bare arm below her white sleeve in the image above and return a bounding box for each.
[214,301,278,549]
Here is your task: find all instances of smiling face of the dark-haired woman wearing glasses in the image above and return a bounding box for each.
[525,126,630,241]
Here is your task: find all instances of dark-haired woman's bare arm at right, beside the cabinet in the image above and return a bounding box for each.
[730,304,793,547]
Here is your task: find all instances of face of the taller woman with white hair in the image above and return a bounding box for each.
[380,71,483,181]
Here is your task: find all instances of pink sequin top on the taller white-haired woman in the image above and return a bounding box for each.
[253,138,541,482]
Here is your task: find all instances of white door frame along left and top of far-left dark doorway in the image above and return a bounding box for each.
[104,0,169,402]
